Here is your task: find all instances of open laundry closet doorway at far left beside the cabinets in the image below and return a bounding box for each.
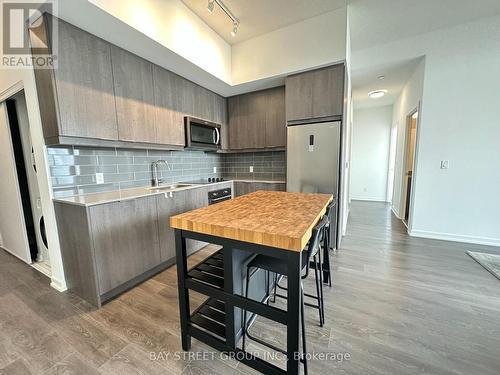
[4,90,50,275]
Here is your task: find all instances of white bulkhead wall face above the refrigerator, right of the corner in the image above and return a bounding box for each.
[232,8,347,85]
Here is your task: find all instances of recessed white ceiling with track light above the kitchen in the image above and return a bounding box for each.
[182,0,346,44]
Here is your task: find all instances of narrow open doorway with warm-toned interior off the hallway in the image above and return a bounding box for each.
[403,108,419,227]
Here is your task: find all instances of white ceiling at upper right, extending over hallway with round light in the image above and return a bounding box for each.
[348,0,500,108]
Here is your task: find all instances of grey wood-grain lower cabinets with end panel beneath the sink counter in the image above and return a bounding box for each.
[54,182,232,307]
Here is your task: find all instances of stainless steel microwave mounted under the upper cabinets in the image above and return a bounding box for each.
[184,116,221,151]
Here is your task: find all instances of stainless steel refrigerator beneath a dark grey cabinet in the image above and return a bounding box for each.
[286,121,341,248]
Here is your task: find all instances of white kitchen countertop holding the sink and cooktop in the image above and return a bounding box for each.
[53,180,285,206]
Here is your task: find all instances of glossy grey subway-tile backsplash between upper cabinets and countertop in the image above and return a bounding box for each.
[47,146,286,198]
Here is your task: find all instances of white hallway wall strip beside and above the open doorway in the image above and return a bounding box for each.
[392,59,425,218]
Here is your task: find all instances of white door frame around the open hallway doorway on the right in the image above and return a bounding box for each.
[400,101,422,234]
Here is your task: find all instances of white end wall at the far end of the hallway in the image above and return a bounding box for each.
[351,106,392,201]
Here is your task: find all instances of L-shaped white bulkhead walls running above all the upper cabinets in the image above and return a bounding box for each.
[62,0,347,96]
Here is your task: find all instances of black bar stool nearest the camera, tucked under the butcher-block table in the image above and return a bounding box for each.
[242,215,328,374]
